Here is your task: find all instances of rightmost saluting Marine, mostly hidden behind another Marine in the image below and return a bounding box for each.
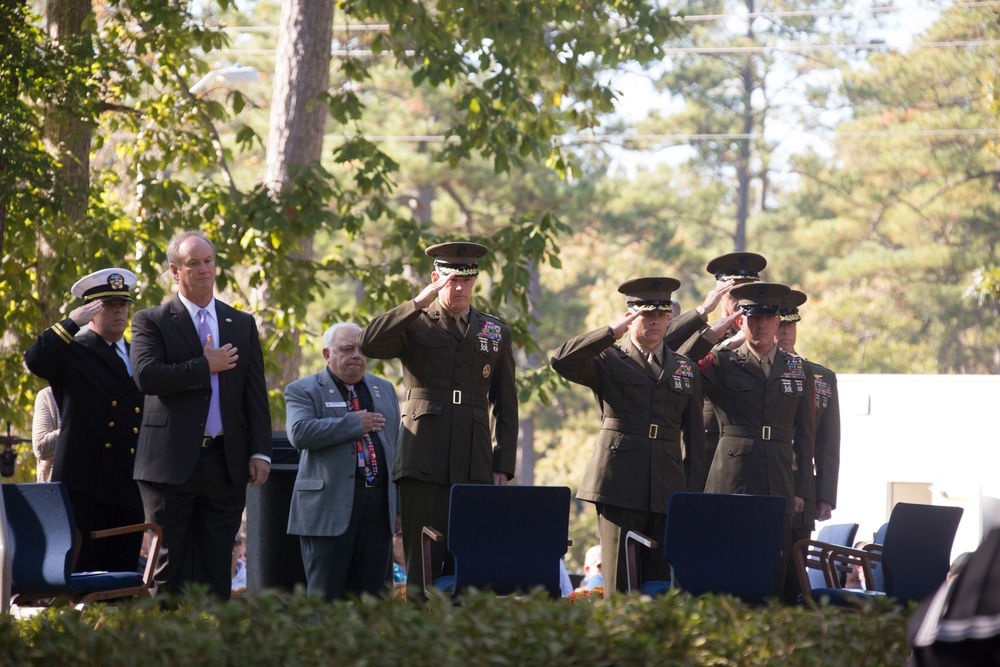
[775,290,840,598]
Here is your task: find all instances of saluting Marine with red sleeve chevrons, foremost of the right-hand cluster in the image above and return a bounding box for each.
[698,283,815,593]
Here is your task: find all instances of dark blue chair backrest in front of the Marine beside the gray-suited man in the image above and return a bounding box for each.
[448,484,570,597]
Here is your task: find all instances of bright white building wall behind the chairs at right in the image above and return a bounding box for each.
[819,375,1000,557]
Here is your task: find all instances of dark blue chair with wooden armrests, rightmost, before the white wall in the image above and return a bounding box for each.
[793,503,963,607]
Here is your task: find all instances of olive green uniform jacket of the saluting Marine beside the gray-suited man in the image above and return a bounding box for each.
[358,301,518,485]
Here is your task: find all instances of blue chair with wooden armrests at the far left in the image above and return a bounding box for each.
[0,482,162,606]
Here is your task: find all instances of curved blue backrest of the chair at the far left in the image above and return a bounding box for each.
[0,482,76,595]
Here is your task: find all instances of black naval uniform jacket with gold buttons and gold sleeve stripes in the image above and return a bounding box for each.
[24,318,145,509]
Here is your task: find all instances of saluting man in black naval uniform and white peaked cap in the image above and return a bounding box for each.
[24,269,143,572]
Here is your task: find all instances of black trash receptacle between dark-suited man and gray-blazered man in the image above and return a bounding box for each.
[247,431,306,592]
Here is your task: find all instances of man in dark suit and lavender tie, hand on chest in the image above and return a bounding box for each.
[132,232,271,599]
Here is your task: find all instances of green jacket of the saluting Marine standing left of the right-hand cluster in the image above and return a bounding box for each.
[552,327,707,514]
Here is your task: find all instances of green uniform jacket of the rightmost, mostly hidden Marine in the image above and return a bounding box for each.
[792,361,840,532]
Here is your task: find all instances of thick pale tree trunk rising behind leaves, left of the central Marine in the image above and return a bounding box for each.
[262,0,334,418]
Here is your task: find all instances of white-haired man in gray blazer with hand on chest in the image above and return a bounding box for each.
[285,322,400,601]
